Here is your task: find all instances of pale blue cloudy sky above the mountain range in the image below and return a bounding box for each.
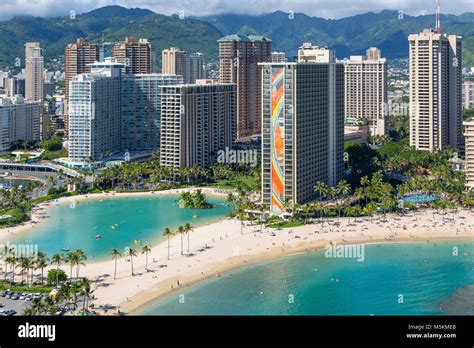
[0,0,474,20]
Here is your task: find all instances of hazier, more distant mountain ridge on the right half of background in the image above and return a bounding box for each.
[201,10,474,66]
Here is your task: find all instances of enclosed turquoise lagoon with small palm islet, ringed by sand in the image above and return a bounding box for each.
[10,195,232,260]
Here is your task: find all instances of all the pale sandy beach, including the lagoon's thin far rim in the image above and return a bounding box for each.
[0,189,474,314]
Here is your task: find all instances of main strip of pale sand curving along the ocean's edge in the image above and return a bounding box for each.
[83,211,474,315]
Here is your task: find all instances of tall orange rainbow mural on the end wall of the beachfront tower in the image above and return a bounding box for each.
[271,68,285,213]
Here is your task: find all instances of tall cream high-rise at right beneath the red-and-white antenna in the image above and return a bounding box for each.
[408,30,464,151]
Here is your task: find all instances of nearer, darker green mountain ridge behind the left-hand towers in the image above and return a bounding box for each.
[0,6,221,67]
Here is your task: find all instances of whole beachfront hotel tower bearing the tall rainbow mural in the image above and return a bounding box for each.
[261,45,344,214]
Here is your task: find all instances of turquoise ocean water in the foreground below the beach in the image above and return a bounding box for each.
[139,240,474,315]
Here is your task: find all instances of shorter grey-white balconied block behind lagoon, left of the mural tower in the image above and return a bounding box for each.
[160,80,236,170]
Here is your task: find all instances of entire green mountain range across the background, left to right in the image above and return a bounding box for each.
[0,6,474,67]
